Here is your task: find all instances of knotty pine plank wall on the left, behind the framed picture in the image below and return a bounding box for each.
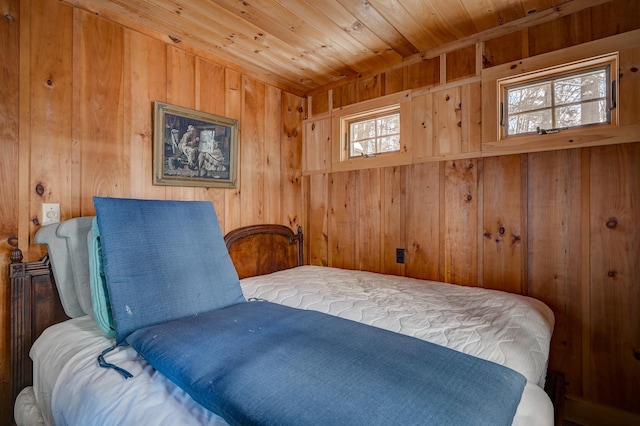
[0,0,305,424]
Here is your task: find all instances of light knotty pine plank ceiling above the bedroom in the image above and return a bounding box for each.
[63,0,604,94]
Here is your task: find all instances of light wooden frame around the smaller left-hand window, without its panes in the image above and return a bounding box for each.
[331,90,411,171]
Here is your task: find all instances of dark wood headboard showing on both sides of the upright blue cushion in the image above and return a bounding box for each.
[9,225,304,420]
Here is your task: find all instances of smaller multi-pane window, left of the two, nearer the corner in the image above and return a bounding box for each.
[346,109,400,158]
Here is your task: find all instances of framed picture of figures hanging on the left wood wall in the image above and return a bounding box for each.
[153,101,238,188]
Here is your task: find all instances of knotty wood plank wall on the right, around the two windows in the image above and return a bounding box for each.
[304,0,640,423]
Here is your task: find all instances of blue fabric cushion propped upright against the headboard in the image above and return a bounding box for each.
[94,197,245,343]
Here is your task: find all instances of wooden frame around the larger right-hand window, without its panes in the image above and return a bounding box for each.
[496,52,618,142]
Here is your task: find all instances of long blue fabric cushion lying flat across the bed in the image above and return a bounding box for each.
[127,302,526,426]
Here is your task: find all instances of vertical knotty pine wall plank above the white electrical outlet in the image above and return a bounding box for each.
[28,2,72,254]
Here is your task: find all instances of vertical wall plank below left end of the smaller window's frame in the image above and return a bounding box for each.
[328,172,358,269]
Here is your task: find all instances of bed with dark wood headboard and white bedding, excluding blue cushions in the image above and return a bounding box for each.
[11,199,554,425]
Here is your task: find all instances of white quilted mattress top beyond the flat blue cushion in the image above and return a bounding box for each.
[241,266,554,387]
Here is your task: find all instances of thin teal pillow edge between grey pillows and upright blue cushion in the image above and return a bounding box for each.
[87,217,116,337]
